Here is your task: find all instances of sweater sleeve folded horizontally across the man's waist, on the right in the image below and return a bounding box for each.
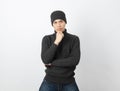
[52,37,81,67]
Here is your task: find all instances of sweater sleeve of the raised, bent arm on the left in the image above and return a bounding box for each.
[41,36,57,64]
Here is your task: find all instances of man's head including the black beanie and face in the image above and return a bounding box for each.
[51,10,67,32]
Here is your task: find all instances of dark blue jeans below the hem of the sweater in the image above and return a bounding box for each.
[39,80,79,91]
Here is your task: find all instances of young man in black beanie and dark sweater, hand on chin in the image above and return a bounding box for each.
[39,10,80,91]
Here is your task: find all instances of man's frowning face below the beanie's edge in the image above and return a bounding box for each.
[53,19,66,32]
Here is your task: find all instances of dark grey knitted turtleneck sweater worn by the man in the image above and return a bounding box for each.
[41,30,80,83]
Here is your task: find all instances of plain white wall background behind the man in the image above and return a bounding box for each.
[0,0,120,91]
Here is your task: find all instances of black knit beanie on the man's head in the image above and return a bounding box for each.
[51,10,67,25]
